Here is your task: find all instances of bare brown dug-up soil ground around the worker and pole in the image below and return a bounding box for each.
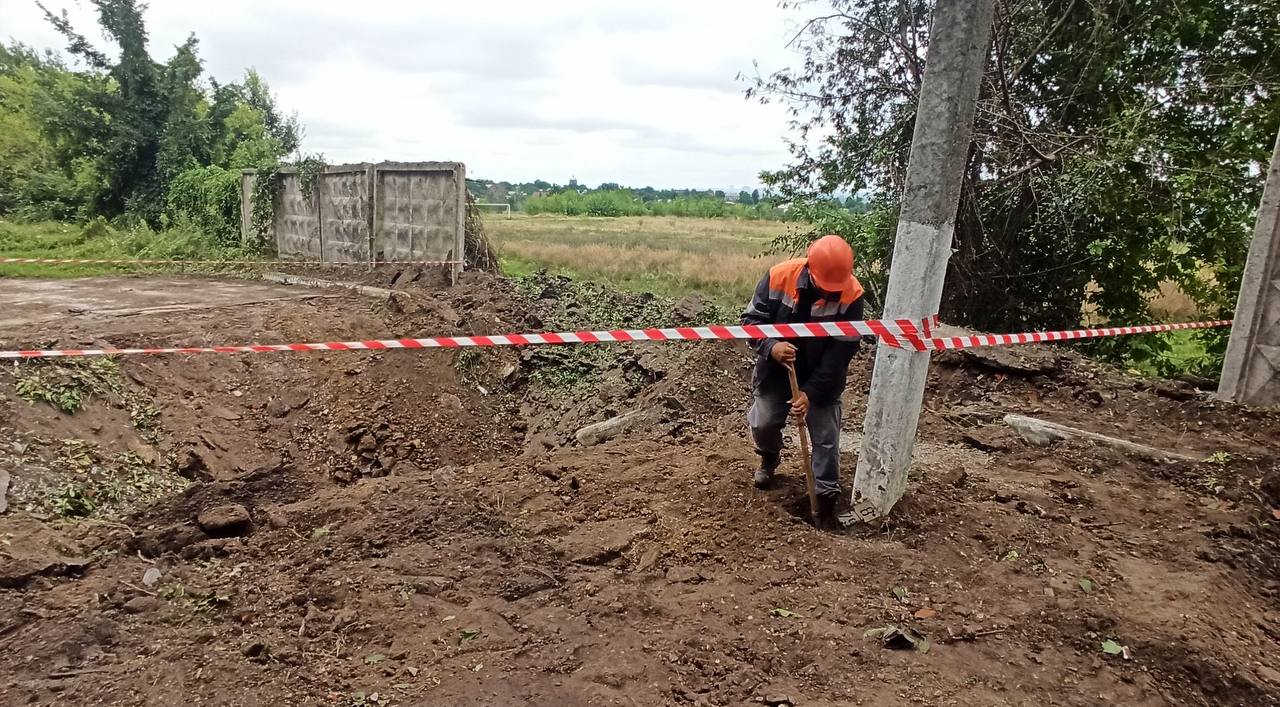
[0,275,1280,706]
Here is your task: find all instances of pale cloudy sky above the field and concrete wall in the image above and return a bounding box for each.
[0,0,797,188]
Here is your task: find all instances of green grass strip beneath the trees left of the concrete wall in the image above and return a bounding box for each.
[0,219,252,278]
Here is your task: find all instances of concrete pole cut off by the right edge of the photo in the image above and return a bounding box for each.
[1217,124,1280,406]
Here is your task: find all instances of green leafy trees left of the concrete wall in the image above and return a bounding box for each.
[15,0,301,226]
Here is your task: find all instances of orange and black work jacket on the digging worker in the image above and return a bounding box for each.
[742,257,863,405]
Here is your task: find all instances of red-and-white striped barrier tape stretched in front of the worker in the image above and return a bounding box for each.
[0,316,1231,359]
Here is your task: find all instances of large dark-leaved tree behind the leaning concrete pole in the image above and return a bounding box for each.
[749,0,1280,366]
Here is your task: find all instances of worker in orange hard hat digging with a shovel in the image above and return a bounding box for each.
[742,236,863,528]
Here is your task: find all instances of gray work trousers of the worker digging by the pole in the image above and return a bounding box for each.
[746,394,841,494]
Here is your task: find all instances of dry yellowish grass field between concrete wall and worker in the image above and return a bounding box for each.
[485,214,795,307]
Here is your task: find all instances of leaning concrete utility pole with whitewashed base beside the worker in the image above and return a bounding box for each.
[854,0,993,520]
